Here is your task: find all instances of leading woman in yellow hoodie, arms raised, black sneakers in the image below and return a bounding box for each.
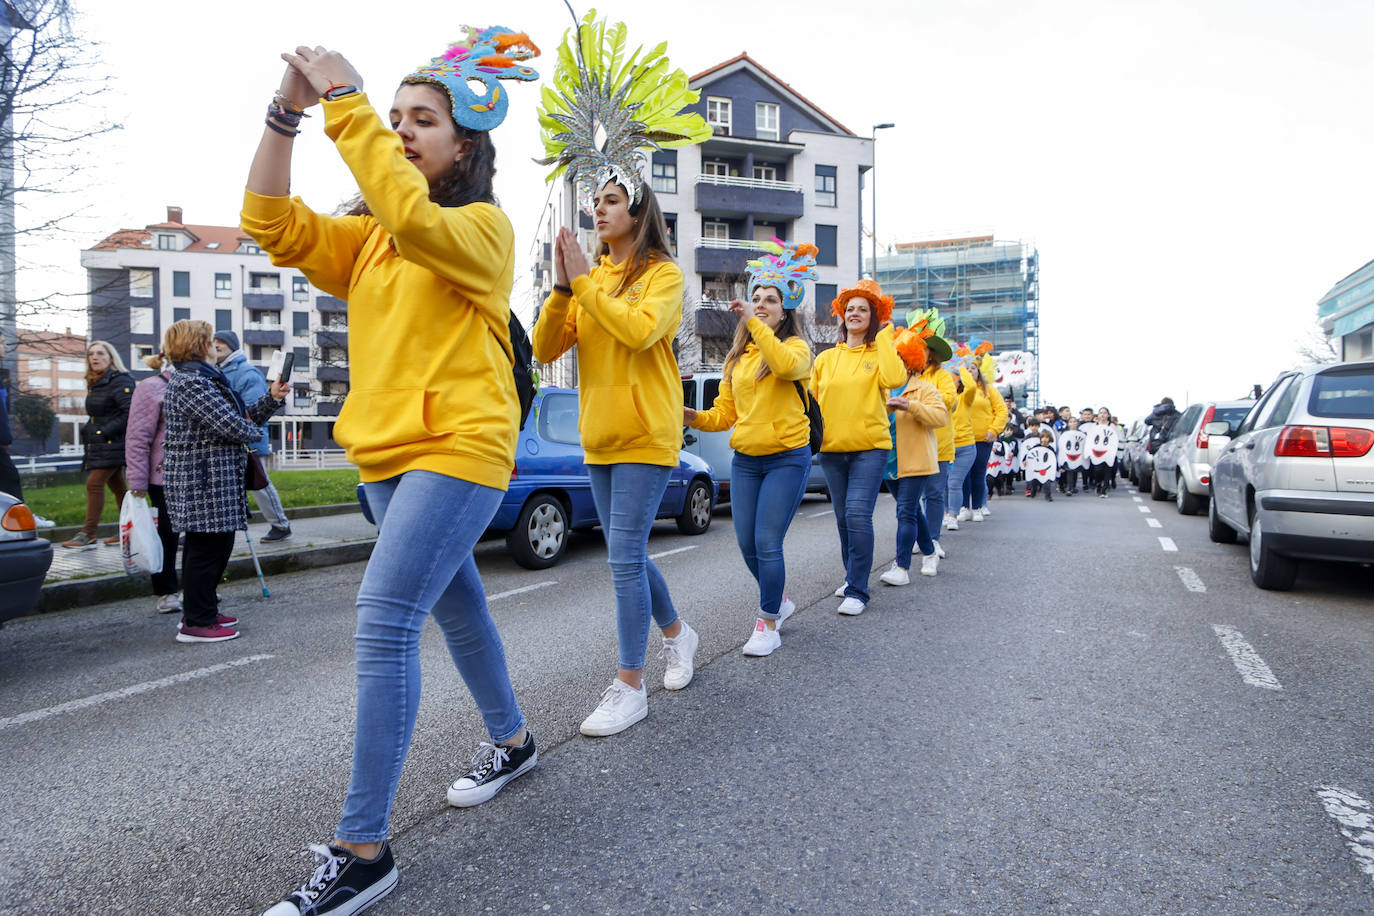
[242,35,539,916]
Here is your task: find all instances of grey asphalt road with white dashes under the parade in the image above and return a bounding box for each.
[0,482,1374,915]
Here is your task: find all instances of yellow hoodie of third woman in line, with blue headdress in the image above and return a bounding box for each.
[691,317,811,456]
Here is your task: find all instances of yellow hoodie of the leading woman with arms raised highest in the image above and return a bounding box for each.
[242,92,519,490]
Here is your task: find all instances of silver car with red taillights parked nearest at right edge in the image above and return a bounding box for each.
[1202,361,1374,589]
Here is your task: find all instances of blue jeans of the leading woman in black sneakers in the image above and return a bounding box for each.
[334,471,525,843]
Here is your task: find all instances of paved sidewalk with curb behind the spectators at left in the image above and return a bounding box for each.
[34,509,376,611]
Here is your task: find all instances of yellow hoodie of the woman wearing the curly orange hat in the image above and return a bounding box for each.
[811,324,907,452]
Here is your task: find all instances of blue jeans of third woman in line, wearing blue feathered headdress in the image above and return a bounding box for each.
[730,445,811,621]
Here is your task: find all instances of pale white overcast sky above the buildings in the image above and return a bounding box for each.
[13,0,1374,420]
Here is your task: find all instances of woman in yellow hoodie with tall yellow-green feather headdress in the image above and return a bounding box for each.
[532,14,710,736]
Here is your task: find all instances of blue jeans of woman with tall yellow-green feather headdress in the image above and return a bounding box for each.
[587,464,677,672]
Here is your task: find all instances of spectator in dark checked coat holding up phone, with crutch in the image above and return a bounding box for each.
[162,320,290,643]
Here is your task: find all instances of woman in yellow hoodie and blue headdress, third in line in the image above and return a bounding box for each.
[683,239,816,656]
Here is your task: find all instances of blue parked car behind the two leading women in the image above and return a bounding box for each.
[357,387,717,570]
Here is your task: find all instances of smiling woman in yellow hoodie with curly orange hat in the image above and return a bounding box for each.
[811,280,907,615]
